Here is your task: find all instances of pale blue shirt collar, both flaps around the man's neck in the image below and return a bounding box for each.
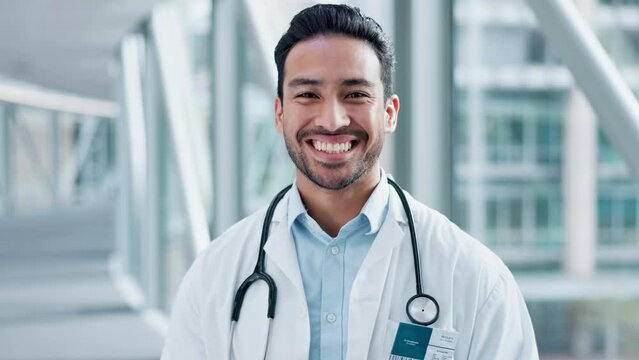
[288,169,389,234]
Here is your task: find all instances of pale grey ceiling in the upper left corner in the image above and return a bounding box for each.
[0,0,158,100]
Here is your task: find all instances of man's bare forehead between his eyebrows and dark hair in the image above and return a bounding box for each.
[284,35,382,86]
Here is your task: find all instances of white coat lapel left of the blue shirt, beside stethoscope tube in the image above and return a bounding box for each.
[264,194,305,298]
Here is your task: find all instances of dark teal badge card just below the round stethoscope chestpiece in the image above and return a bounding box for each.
[389,322,433,360]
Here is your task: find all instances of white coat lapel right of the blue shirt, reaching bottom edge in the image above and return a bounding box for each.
[347,190,407,359]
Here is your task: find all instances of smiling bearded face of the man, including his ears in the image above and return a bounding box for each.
[275,35,399,190]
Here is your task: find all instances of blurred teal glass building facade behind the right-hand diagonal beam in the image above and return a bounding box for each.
[453,0,639,359]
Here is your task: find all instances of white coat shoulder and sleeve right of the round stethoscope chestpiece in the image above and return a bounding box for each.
[402,197,538,359]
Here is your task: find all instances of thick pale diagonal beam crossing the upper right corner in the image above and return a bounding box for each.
[528,0,639,181]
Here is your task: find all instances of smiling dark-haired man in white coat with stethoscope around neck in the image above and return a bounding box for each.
[162,5,538,360]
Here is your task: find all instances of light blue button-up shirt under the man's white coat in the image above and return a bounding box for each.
[288,178,389,360]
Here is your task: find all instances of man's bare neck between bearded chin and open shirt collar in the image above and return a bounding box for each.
[295,165,381,237]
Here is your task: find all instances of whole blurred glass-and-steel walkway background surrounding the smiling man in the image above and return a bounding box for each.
[0,0,639,359]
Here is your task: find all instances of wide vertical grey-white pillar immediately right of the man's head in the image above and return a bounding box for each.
[393,0,453,215]
